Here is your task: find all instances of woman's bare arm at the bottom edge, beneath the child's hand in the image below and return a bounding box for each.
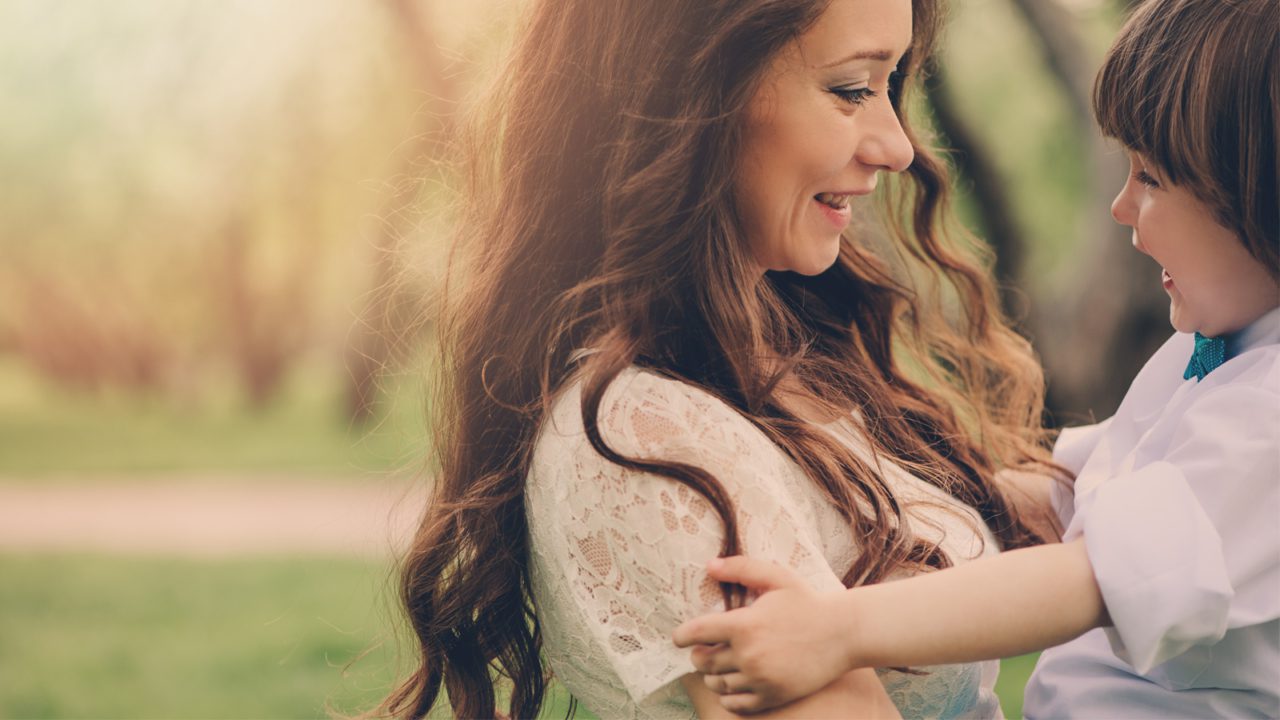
[681,669,900,720]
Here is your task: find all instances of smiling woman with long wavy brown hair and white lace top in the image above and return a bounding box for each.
[385,0,1044,717]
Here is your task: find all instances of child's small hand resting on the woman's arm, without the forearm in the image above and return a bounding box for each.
[672,556,852,712]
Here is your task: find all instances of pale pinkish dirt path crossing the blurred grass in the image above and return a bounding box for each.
[0,475,425,557]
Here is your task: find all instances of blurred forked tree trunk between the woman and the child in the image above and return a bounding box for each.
[928,0,1169,423]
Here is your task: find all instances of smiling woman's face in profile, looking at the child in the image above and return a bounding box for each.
[736,0,914,275]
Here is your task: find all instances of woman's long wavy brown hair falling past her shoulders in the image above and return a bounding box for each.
[381,0,1044,717]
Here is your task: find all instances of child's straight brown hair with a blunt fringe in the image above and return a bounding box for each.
[1093,0,1280,278]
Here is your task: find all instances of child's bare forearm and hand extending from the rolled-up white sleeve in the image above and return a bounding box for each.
[673,538,1107,711]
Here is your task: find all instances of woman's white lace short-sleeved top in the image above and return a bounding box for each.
[525,368,1000,719]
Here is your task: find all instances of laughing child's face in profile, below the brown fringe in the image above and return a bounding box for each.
[1111,151,1280,337]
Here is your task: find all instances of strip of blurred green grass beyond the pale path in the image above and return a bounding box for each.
[0,356,426,479]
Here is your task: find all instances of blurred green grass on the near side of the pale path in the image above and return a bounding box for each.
[0,555,1036,720]
